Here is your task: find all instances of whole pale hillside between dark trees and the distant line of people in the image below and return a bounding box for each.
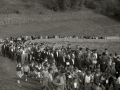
[0,0,120,37]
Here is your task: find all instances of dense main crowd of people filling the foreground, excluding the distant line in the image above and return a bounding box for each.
[0,37,120,90]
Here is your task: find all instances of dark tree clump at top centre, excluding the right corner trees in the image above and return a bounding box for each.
[43,0,84,11]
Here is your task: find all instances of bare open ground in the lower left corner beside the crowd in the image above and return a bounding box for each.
[0,57,40,90]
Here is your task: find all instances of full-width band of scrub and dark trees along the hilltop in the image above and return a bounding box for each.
[0,0,120,17]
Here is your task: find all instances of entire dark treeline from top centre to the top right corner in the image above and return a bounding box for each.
[43,0,120,16]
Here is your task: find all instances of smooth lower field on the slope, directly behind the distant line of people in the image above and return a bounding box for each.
[0,12,120,37]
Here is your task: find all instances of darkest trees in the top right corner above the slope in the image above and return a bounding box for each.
[84,0,120,16]
